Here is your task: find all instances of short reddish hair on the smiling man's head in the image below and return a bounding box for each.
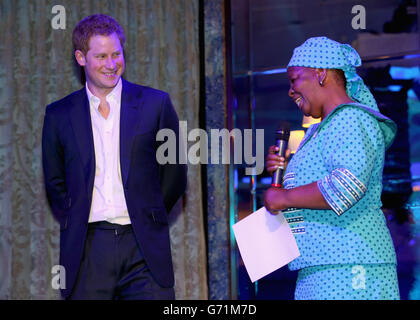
[72,14,125,55]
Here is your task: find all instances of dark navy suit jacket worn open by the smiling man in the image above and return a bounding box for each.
[42,79,187,297]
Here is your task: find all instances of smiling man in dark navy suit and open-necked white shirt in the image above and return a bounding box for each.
[42,15,186,299]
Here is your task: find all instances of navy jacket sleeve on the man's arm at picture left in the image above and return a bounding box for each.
[42,107,67,218]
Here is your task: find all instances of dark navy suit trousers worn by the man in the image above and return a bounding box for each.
[68,221,175,300]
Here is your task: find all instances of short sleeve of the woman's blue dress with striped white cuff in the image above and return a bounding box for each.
[317,107,384,215]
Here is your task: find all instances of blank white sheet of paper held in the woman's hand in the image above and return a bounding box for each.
[232,207,300,282]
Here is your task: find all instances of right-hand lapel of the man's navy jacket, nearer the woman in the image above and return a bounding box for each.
[120,79,143,186]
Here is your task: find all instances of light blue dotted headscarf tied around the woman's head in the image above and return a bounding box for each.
[287,37,379,111]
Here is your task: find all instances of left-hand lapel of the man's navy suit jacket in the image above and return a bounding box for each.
[70,88,95,195]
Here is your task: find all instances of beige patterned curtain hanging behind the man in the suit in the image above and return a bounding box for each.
[0,0,207,299]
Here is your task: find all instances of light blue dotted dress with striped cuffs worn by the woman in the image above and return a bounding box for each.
[283,103,399,300]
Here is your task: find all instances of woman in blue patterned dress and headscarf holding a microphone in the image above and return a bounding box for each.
[264,37,399,300]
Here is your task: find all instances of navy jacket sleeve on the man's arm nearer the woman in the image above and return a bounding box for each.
[159,94,187,213]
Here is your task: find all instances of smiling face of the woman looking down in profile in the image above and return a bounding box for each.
[287,67,322,118]
